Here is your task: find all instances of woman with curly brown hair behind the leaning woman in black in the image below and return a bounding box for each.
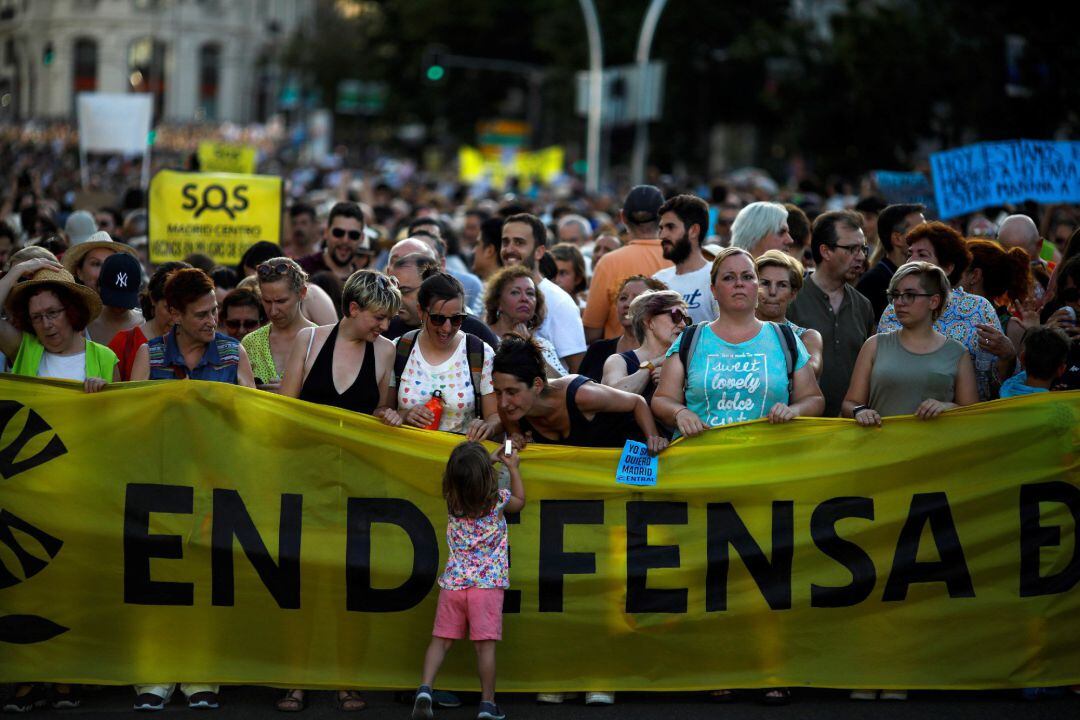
[484,266,567,379]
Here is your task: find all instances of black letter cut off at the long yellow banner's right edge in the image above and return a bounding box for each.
[1020,480,1080,598]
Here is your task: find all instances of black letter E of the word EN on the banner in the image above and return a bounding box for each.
[124,483,194,606]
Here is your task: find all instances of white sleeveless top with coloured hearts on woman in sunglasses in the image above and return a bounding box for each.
[390,332,495,434]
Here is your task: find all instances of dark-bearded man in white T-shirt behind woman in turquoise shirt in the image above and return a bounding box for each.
[652,195,719,323]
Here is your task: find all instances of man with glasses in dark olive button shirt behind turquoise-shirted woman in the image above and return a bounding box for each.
[787,210,877,418]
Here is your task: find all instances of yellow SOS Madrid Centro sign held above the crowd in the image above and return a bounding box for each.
[149,171,283,264]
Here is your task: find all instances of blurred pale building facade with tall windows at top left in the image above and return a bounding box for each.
[0,0,314,123]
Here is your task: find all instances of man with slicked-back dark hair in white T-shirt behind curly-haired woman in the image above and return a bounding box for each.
[500,213,586,372]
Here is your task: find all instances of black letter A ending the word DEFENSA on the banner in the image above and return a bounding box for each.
[881,492,975,602]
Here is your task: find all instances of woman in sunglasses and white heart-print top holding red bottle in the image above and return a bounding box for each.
[383,272,502,440]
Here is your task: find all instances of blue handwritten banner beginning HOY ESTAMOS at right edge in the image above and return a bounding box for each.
[930,140,1080,218]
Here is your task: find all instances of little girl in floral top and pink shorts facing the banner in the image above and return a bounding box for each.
[413,441,525,720]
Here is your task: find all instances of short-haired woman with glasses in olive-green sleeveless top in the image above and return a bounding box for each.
[841,261,978,427]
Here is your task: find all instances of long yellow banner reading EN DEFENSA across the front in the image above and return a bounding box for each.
[0,376,1080,691]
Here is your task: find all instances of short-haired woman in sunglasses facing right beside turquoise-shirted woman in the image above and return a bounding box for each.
[604,290,690,403]
